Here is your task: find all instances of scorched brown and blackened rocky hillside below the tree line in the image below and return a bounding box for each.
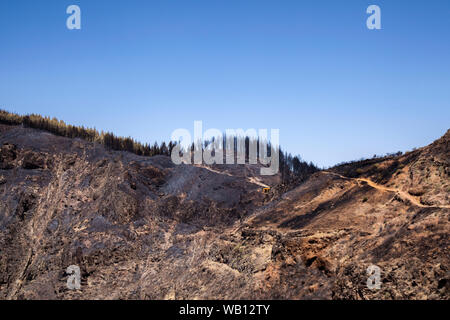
[0,127,450,299]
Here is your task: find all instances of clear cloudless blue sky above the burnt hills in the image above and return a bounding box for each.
[0,0,450,166]
